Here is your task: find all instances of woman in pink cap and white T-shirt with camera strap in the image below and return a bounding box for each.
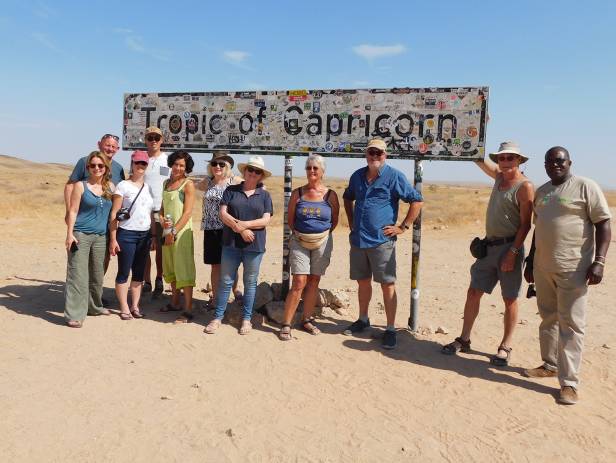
[109,151,155,320]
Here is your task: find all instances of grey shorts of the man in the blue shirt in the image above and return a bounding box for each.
[349,241,396,283]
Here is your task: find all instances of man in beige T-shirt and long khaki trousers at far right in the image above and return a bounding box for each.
[524,146,612,405]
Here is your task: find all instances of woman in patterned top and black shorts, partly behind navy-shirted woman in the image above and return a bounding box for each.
[199,151,242,309]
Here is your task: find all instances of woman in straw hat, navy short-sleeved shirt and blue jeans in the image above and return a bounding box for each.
[204,156,273,334]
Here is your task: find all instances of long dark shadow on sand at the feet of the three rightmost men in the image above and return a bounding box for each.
[343,328,558,397]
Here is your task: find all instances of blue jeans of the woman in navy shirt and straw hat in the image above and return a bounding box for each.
[215,246,264,320]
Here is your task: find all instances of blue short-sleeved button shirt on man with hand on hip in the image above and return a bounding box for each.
[342,164,423,248]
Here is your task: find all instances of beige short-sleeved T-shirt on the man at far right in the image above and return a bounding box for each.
[533,176,611,272]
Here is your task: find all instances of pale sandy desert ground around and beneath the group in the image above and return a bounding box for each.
[0,157,616,462]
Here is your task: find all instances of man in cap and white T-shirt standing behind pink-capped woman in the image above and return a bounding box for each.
[143,126,171,297]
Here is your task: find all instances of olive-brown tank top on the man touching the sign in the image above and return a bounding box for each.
[486,174,528,239]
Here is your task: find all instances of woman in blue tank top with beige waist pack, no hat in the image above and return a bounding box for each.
[279,154,340,341]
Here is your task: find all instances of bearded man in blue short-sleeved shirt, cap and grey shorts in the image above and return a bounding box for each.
[342,139,423,349]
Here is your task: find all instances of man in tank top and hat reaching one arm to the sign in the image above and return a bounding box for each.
[441,141,534,366]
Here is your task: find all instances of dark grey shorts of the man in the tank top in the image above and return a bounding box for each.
[471,243,524,299]
